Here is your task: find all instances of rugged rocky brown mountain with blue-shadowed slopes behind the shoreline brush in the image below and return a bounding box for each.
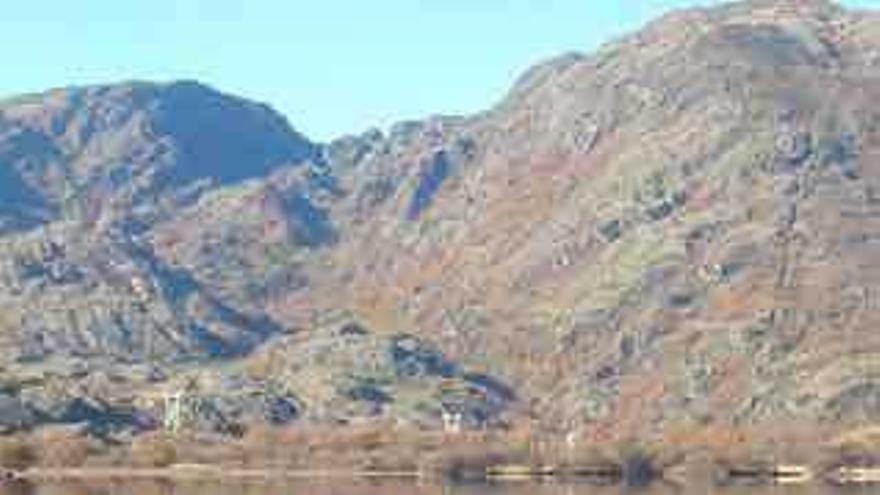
[0,0,880,437]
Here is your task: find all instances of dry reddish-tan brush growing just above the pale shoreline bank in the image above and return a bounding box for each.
[8,422,880,485]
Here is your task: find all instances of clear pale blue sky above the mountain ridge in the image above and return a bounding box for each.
[0,0,880,140]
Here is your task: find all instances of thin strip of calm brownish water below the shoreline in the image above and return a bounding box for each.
[0,481,868,495]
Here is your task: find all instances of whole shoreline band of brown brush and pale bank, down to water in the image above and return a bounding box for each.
[0,422,880,485]
